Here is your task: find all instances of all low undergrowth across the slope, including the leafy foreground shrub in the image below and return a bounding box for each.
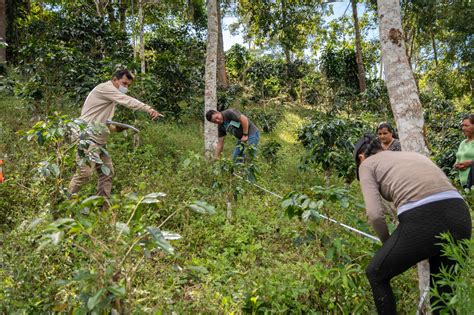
[0,97,472,314]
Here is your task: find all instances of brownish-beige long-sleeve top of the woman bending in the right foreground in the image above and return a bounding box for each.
[359,151,455,242]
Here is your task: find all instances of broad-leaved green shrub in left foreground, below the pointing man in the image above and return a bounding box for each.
[29,193,215,313]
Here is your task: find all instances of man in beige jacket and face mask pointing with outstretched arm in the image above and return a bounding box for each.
[69,69,162,199]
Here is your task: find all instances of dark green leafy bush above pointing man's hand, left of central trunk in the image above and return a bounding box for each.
[132,24,205,115]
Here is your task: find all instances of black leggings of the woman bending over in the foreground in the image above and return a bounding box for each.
[366,198,471,314]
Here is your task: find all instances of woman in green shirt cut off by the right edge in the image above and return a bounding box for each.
[454,114,474,189]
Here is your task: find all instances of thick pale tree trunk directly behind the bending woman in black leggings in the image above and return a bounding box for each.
[377,0,429,314]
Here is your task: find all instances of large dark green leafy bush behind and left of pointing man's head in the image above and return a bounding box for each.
[13,3,130,112]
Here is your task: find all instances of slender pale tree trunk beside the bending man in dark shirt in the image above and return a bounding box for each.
[204,0,219,158]
